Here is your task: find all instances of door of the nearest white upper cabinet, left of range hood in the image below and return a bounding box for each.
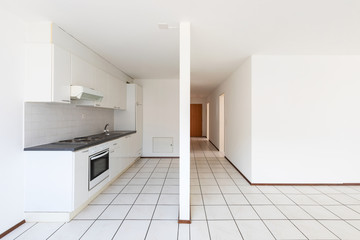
[52,45,71,103]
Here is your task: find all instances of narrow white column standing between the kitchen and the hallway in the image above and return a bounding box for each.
[179,22,190,223]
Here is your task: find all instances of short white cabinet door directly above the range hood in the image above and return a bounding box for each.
[71,54,96,90]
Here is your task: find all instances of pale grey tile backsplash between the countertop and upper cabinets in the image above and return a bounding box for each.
[24,103,114,147]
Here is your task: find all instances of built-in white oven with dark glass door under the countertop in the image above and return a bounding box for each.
[89,148,109,190]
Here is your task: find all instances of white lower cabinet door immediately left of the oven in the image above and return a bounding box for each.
[73,149,89,209]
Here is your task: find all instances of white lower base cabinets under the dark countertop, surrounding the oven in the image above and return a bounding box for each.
[25,134,141,222]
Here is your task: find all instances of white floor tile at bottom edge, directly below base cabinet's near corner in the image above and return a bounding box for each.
[49,220,94,240]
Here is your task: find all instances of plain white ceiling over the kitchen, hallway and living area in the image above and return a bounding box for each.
[0,0,360,97]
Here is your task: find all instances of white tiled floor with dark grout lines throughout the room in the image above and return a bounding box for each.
[4,138,360,240]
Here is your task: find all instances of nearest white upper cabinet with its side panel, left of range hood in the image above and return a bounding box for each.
[25,43,71,103]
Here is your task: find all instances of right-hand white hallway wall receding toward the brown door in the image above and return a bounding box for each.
[207,58,251,179]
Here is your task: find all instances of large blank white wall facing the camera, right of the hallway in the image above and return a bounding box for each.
[252,56,360,183]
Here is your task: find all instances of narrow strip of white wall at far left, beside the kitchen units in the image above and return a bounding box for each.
[0,9,25,234]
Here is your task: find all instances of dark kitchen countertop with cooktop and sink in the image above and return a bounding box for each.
[24,131,136,152]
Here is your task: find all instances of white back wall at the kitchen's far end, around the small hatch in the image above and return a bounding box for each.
[135,79,179,157]
